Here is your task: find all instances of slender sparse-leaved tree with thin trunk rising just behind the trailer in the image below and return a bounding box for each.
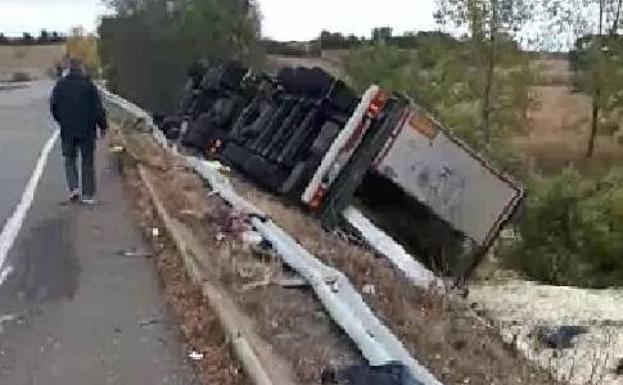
[435,0,535,144]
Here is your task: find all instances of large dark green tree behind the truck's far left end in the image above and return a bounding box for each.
[98,0,261,113]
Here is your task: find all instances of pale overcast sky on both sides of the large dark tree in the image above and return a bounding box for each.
[0,0,435,40]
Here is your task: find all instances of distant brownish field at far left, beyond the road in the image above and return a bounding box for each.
[0,44,65,81]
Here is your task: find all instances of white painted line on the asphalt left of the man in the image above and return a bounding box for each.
[0,129,60,285]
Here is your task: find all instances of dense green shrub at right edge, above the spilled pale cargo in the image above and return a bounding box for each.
[505,170,623,288]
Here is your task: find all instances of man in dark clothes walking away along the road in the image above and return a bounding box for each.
[50,59,108,205]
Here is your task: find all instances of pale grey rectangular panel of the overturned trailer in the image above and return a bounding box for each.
[374,106,523,247]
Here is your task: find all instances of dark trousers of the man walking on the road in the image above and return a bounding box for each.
[62,138,96,197]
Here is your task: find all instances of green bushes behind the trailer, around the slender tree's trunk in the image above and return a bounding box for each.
[345,39,534,179]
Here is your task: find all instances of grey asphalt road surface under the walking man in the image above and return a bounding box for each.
[0,82,198,385]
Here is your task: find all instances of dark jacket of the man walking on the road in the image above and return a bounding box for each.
[50,71,108,140]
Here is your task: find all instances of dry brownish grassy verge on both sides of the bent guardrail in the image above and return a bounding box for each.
[113,121,553,385]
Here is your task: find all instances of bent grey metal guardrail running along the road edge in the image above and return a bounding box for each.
[102,90,442,385]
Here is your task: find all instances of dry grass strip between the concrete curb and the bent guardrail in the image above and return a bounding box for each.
[114,128,362,384]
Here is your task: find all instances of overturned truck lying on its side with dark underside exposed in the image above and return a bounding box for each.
[155,63,524,279]
